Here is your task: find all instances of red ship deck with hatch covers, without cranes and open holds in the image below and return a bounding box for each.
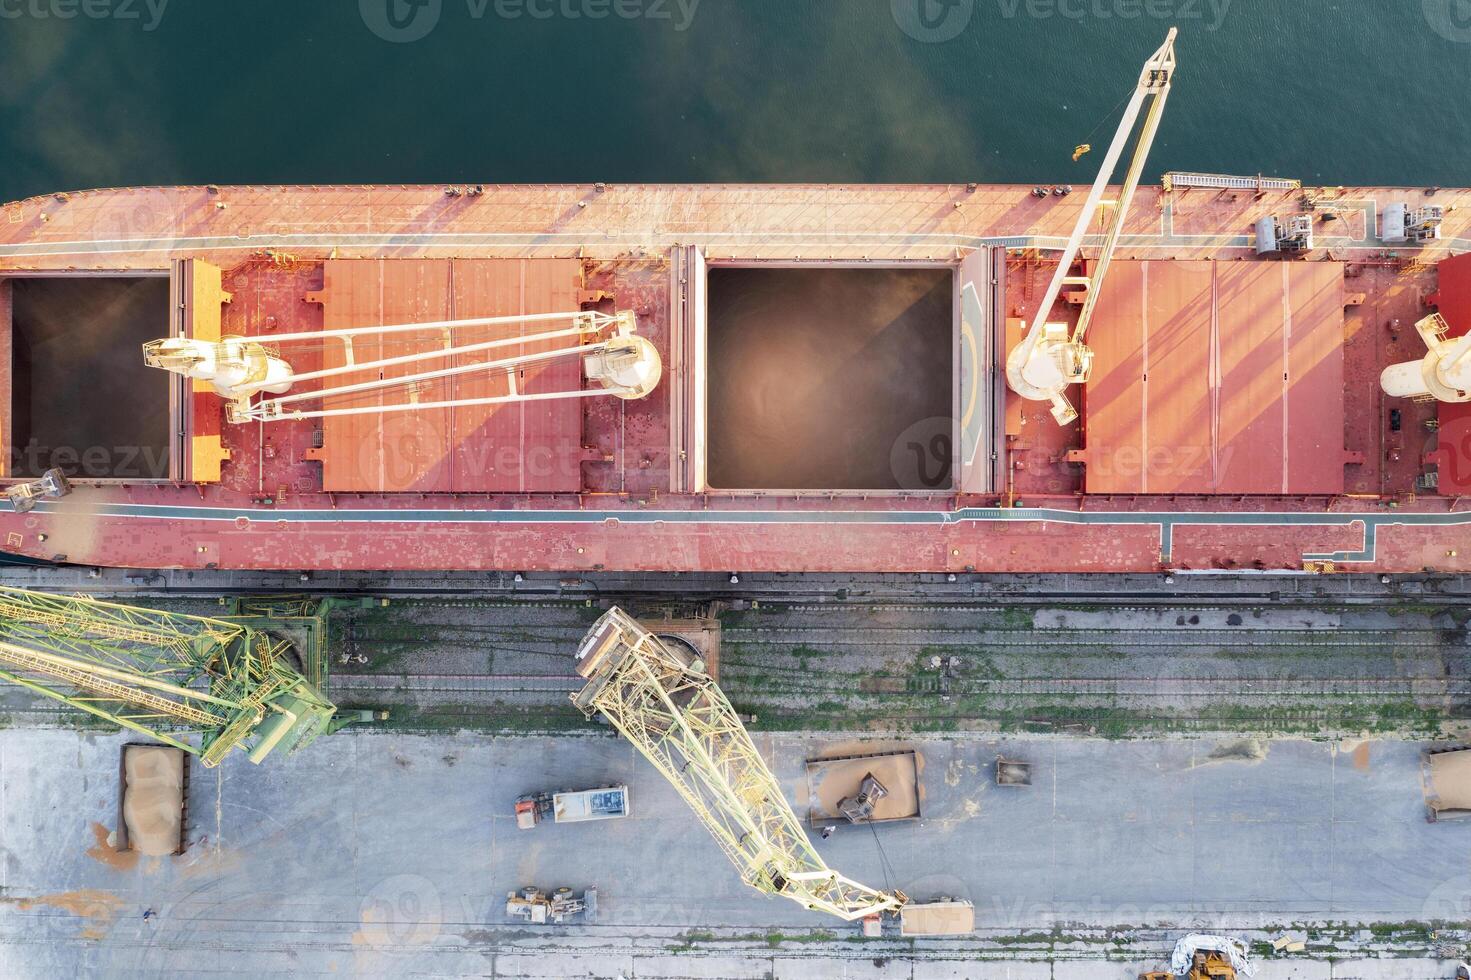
[0,184,1471,572]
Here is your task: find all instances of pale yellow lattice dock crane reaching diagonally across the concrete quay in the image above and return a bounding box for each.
[572,606,908,921]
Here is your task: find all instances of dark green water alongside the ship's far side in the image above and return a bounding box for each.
[0,0,1471,200]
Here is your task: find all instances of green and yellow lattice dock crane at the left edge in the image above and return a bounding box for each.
[0,587,337,767]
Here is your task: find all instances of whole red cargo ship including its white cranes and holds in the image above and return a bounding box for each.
[0,37,1471,575]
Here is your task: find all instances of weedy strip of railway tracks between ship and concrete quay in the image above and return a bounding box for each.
[0,594,1471,733]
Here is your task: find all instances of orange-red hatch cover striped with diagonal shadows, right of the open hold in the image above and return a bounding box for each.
[1074,262,1344,494]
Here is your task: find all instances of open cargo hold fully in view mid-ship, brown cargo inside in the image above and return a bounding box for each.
[708,266,955,490]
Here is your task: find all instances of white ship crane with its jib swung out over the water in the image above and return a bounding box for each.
[1006,28,1177,425]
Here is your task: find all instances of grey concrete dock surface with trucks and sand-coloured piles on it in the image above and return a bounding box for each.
[0,730,1471,977]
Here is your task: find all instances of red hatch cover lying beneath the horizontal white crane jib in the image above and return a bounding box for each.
[310,259,583,493]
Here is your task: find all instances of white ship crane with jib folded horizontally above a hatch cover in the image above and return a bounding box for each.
[143,310,663,422]
